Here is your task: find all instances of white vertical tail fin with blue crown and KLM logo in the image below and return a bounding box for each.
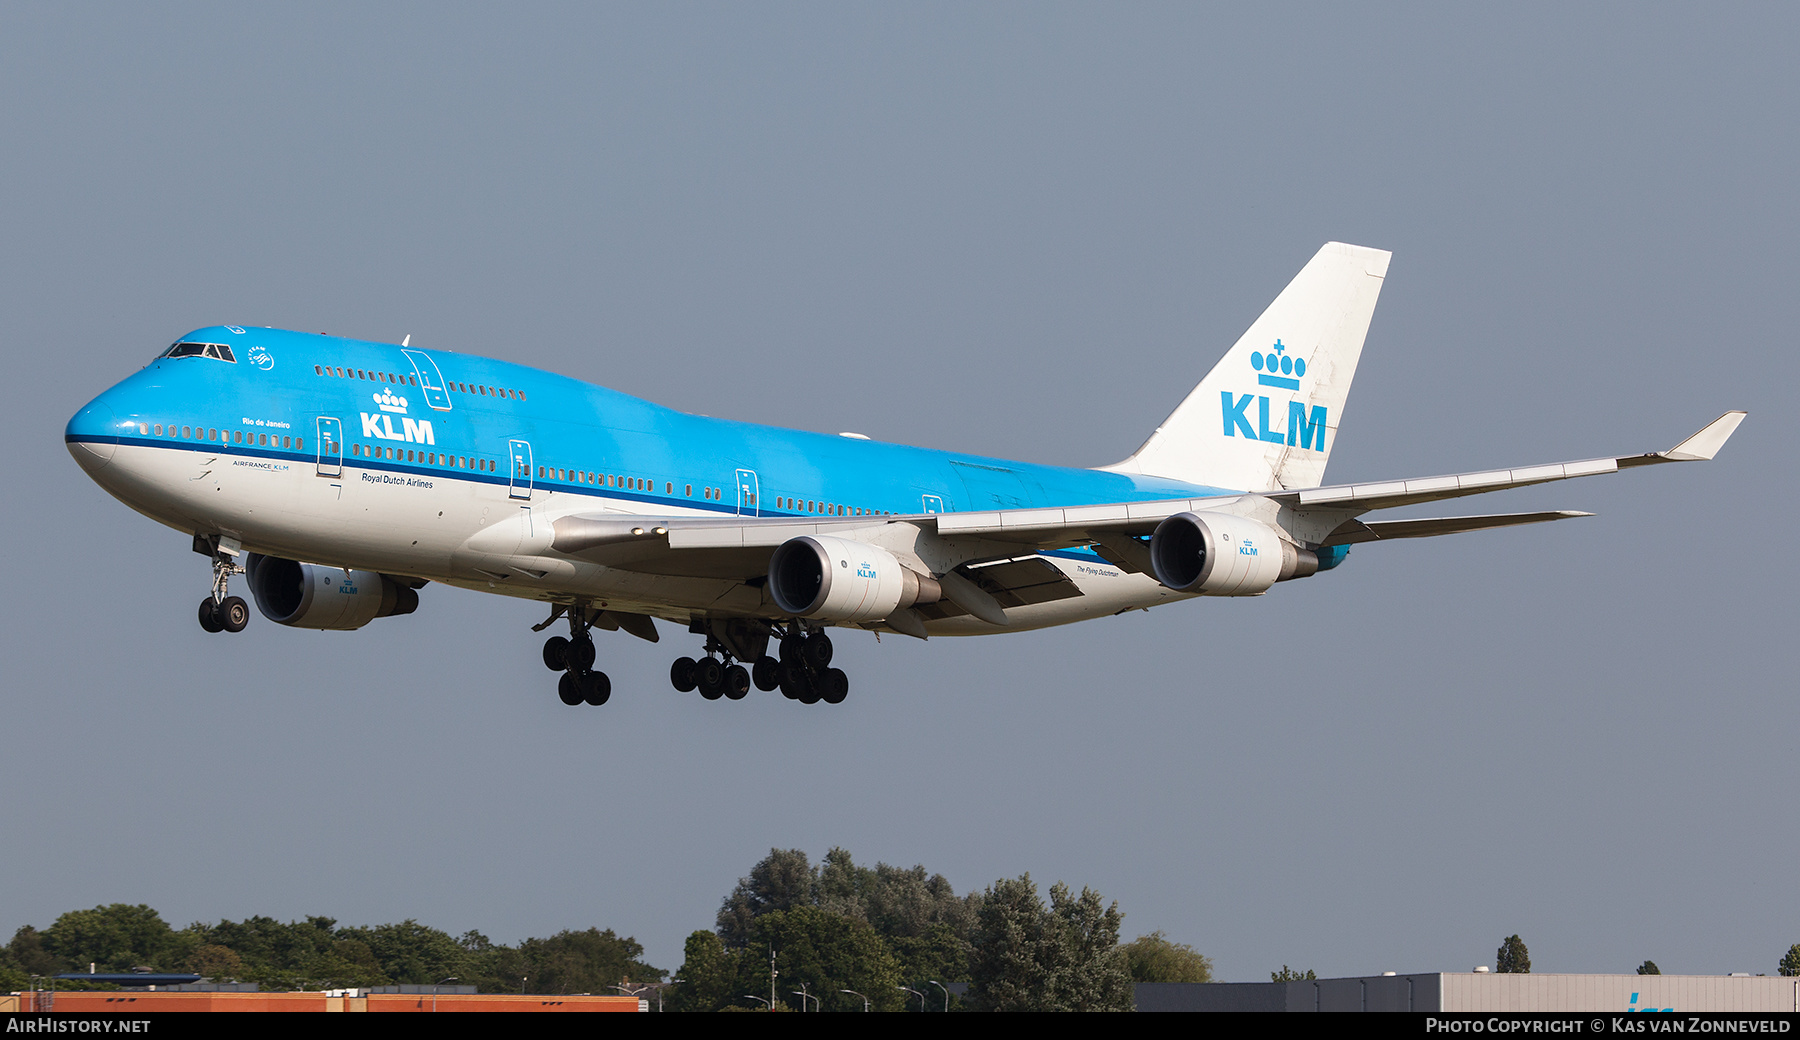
[1103,241,1393,491]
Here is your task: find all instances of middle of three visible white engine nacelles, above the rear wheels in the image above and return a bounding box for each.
[769,534,943,621]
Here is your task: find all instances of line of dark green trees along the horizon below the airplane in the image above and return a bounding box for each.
[0,849,1211,1011]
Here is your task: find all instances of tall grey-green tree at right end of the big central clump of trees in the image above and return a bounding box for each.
[968,874,1132,1011]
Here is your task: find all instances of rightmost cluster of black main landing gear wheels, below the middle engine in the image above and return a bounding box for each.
[670,624,850,704]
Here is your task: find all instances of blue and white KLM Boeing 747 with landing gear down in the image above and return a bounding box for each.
[65,243,1744,705]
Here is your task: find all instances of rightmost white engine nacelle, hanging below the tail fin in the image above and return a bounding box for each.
[1150,513,1319,596]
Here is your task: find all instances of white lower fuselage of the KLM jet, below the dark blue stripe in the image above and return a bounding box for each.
[85,444,1186,635]
